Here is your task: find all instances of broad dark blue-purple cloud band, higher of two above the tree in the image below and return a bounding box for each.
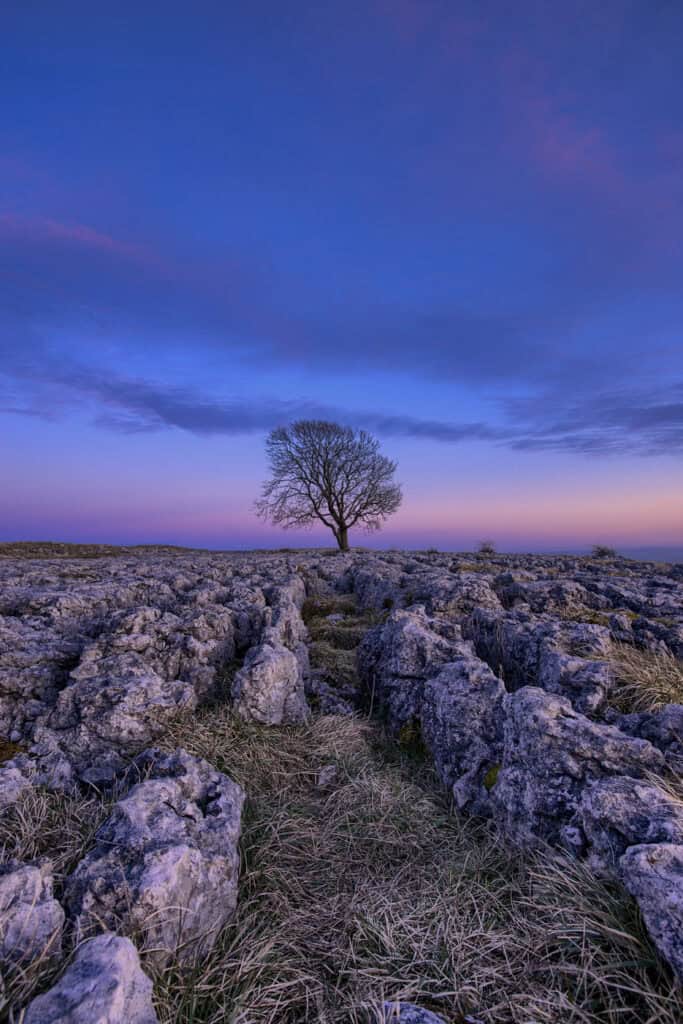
[0,197,671,397]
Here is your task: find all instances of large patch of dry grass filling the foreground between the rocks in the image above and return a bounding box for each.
[147,710,683,1024]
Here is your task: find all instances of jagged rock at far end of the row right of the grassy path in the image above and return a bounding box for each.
[357,607,470,732]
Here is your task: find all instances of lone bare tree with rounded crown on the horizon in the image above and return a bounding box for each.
[256,420,402,551]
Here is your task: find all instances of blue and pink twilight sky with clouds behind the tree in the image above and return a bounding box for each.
[0,0,683,557]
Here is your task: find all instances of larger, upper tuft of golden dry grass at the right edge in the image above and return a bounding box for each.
[611,644,683,712]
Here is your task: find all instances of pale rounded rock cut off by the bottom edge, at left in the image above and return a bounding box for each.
[24,933,158,1024]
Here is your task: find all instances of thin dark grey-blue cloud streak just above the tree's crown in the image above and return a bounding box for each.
[0,359,683,456]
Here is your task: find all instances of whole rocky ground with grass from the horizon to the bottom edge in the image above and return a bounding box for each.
[0,546,683,1024]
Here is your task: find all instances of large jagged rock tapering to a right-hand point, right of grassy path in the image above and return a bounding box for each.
[492,686,665,850]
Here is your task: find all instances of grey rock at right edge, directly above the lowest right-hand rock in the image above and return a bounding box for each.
[578,777,683,873]
